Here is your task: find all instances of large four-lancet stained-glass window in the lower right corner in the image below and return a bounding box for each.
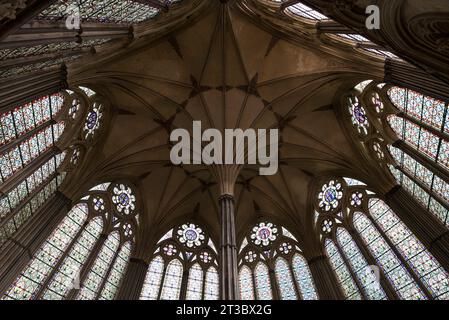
[315,178,449,300]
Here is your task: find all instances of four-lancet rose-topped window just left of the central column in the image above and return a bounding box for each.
[140,222,219,300]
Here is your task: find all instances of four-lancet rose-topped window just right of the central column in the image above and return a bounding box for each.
[239,220,317,300]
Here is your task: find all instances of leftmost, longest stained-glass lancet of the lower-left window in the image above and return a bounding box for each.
[3,204,87,300]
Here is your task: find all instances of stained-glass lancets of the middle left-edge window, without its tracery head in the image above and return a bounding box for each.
[0,91,73,246]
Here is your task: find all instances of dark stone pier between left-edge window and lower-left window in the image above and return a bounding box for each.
[0,192,71,295]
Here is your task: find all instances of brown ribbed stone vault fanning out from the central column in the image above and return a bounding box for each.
[61,1,384,255]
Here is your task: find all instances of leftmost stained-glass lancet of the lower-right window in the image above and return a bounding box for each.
[325,239,362,300]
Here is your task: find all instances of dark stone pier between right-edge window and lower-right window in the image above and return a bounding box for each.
[385,186,449,272]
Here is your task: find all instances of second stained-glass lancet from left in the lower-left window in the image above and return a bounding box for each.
[42,217,103,300]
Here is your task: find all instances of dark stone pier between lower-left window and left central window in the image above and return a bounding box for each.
[115,258,149,300]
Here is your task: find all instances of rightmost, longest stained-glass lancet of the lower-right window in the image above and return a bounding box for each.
[369,199,449,299]
